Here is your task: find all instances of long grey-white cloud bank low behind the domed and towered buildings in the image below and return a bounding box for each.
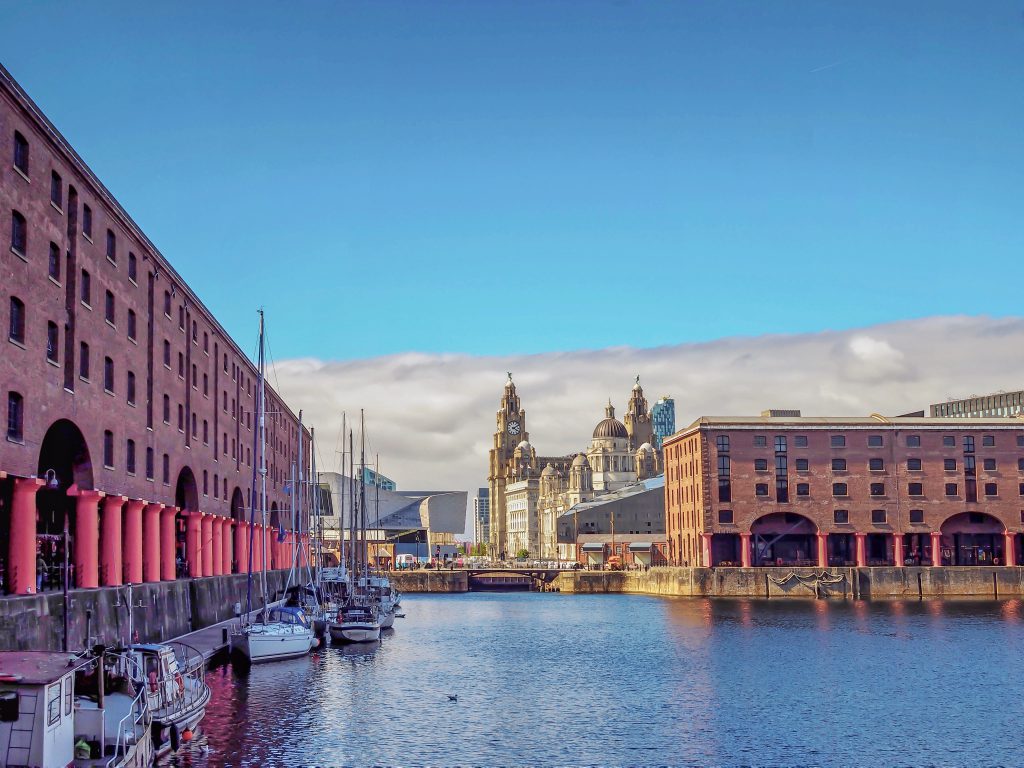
[270,316,1024,501]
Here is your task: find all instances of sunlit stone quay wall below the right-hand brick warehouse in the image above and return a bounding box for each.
[552,566,1024,599]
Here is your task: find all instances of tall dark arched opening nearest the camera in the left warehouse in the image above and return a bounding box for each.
[33,419,93,591]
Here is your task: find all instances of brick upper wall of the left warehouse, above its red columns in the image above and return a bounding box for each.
[0,68,308,587]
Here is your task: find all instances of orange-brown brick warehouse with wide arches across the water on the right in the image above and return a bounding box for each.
[665,412,1024,567]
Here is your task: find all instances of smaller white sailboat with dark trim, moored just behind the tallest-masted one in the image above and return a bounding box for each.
[328,414,381,643]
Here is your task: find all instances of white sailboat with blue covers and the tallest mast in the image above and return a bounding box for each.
[230,309,316,664]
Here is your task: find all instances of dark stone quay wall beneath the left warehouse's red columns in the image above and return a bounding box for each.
[0,570,288,650]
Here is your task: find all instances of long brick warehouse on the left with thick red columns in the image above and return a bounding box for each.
[0,67,309,594]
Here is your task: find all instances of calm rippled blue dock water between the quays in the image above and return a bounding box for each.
[188,593,1024,766]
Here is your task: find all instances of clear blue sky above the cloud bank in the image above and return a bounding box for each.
[0,0,1024,359]
